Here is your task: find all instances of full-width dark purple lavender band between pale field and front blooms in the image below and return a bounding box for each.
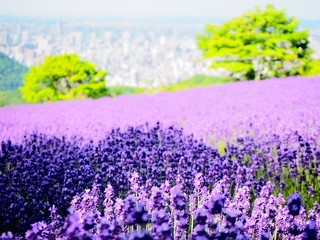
[0,124,320,237]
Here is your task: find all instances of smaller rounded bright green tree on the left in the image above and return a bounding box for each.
[19,54,107,103]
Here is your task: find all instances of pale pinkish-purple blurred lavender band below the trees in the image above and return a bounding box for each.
[0,77,320,144]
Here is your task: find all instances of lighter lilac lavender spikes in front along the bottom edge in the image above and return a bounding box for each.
[3,181,320,240]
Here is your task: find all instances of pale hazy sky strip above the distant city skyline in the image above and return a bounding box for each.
[0,0,320,20]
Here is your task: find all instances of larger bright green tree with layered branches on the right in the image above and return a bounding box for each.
[197,5,312,80]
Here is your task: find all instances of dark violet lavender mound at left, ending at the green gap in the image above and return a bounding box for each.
[0,125,219,232]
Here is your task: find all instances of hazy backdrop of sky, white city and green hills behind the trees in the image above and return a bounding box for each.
[0,0,320,105]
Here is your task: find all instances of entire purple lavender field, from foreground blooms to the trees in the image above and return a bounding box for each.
[0,77,320,240]
